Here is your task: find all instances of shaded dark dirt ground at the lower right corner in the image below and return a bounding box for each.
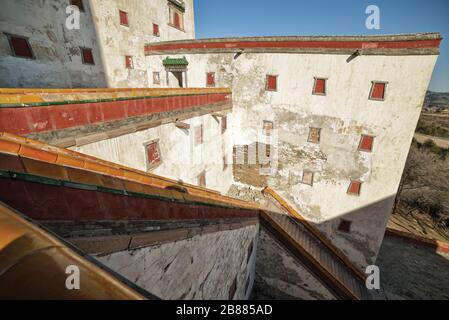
[376,236,449,300]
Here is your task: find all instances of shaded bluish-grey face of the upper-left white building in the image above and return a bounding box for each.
[0,0,106,87]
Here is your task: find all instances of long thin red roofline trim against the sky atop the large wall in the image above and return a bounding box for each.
[145,39,441,52]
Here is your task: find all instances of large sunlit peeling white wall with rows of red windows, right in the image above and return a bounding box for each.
[147,53,437,267]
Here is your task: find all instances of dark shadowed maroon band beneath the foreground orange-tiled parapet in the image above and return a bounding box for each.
[0,179,258,221]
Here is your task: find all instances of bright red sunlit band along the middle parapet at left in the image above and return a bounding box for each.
[0,93,231,135]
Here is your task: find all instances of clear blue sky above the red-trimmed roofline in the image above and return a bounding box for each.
[194,0,449,92]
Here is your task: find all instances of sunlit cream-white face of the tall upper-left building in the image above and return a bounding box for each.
[91,0,195,88]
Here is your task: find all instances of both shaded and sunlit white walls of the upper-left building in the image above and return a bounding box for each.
[0,0,195,88]
